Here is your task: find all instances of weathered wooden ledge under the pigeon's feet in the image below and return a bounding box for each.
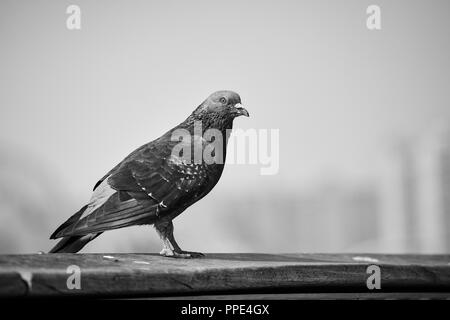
[0,253,450,299]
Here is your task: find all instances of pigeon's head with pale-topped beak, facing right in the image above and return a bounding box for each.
[193,90,249,127]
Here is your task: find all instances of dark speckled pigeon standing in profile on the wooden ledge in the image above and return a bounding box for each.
[49,90,249,258]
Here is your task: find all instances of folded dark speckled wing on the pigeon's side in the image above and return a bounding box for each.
[55,148,212,237]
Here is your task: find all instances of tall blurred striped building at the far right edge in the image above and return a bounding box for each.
[379,125,450,253]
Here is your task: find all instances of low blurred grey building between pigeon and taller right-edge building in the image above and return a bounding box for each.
[217,180,379,252]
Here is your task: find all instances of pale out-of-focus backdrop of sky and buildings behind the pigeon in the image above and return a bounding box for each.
[0,0,450,253]
